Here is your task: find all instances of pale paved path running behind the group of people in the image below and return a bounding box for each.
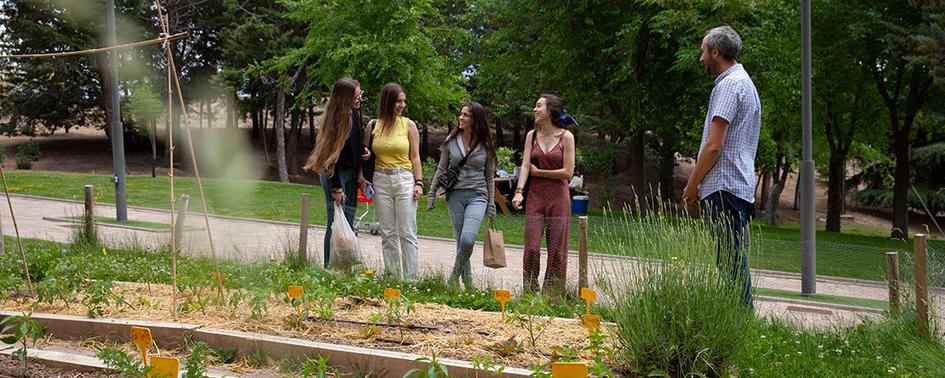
[0,195,945,326]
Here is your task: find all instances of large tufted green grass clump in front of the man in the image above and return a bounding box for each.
[595,205,754,377]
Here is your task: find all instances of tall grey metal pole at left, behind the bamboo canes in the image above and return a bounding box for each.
[105,0,128,222]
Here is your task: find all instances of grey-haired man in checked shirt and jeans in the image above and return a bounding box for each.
[683,26,761,305]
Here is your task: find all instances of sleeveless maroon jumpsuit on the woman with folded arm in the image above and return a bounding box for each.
[522,134,571,293]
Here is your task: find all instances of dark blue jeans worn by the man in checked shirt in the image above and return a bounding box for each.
[702,191,754,306]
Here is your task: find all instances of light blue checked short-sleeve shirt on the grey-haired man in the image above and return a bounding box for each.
[699,64,761,203]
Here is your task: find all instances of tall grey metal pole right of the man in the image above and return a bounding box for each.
[800,0,817,296]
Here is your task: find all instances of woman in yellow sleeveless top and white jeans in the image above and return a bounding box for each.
[365,83,423,282]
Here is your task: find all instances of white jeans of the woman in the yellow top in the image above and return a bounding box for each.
[373,169,420,282]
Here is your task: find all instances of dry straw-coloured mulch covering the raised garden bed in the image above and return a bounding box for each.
[0,282,609,368]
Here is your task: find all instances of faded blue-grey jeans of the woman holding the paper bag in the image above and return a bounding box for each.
[446,189,489,289]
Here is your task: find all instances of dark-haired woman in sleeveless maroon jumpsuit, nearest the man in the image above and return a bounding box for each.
[512,94,574,294]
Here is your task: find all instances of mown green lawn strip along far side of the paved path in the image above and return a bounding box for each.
[7,171,945,280]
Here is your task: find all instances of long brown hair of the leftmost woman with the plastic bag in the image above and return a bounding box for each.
[302,78,361,175]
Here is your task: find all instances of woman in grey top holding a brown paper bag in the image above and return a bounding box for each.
[427,102,496,289]
